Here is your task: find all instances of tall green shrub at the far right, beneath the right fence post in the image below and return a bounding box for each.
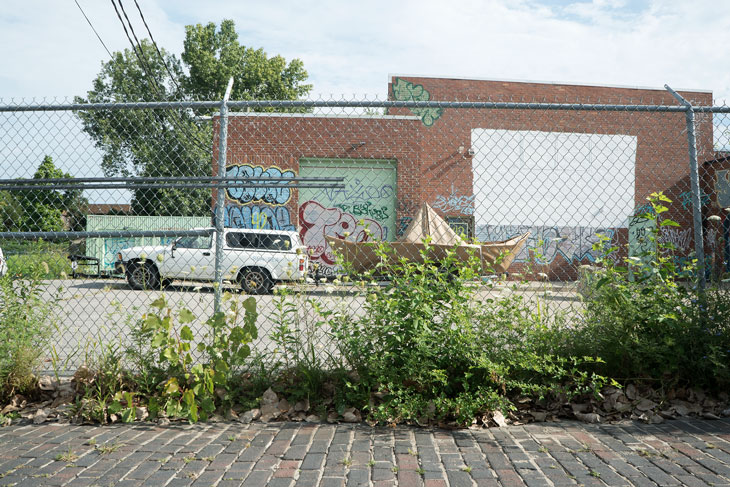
[566,193,730,391]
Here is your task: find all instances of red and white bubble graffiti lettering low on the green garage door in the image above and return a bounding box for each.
[299,200,386,269]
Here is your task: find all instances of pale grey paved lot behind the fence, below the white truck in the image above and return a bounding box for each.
[39,279,581,373]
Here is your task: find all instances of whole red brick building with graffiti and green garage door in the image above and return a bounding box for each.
[214,76,712,279]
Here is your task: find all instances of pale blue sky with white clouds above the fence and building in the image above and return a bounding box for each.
[0,0,730,103]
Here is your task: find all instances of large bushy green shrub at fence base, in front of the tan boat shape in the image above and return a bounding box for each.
[331,243,603,424]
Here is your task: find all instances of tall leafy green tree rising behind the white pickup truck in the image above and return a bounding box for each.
[76,20,311,215]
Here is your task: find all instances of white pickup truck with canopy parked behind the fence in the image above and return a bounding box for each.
[114,228,309,294]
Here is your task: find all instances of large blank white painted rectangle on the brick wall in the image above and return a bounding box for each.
[471,128,637,232]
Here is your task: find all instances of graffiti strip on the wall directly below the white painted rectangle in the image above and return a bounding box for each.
[477,225,617,264]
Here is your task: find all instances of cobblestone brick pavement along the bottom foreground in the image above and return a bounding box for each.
[0,419,730,487]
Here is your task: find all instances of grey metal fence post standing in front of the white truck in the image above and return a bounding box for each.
[213,77,233,313]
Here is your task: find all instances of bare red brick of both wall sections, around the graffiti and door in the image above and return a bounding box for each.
[213,77,712,279]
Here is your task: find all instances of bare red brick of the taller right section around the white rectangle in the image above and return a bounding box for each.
[388,76,712,278]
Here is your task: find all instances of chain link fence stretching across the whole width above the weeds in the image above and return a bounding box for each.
[0,84,730,371]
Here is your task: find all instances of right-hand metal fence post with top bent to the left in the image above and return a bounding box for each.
[664,85,707,290]
